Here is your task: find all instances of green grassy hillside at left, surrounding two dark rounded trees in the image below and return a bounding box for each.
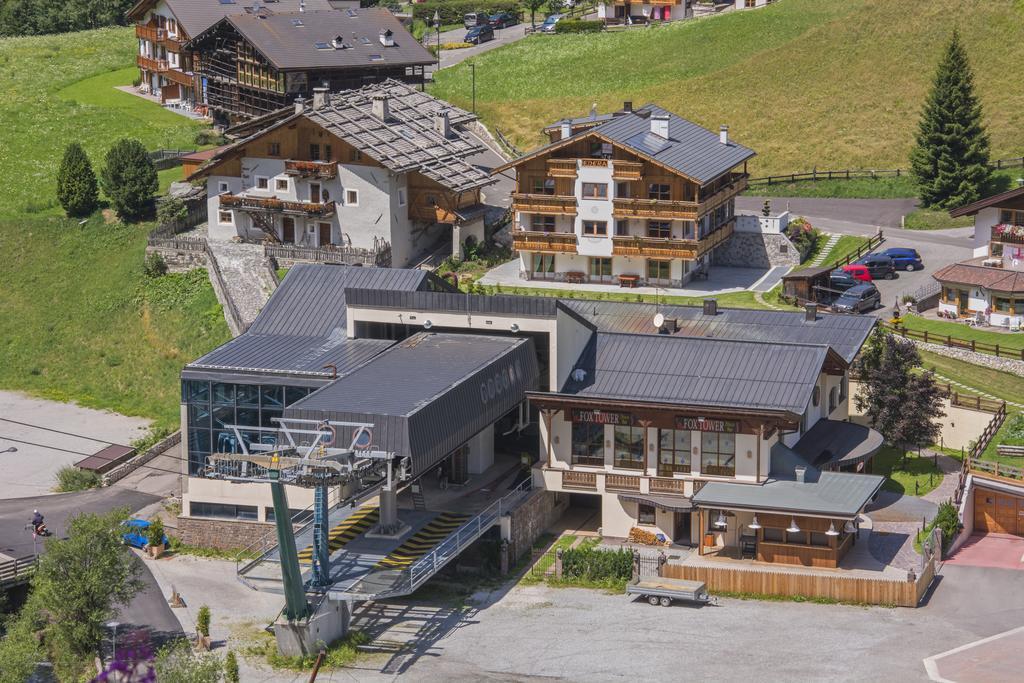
[0,28,230,428]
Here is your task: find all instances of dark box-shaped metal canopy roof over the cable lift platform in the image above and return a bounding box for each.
[285,333,540,475]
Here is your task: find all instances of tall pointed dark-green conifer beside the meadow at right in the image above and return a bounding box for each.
[910,31,991,209]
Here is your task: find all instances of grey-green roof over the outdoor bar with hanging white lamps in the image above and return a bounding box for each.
[693,443,885,519]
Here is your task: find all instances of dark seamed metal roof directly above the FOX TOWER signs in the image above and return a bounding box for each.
[561,333,829,415]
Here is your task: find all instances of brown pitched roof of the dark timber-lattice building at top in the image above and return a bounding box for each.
[225,5,435,71]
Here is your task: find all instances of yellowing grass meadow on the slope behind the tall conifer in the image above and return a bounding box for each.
[431,0,1024,175]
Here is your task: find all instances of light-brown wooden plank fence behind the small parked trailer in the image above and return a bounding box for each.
[662,557,935,607]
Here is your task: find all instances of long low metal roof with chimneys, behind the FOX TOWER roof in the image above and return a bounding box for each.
[561,299,876,364]
